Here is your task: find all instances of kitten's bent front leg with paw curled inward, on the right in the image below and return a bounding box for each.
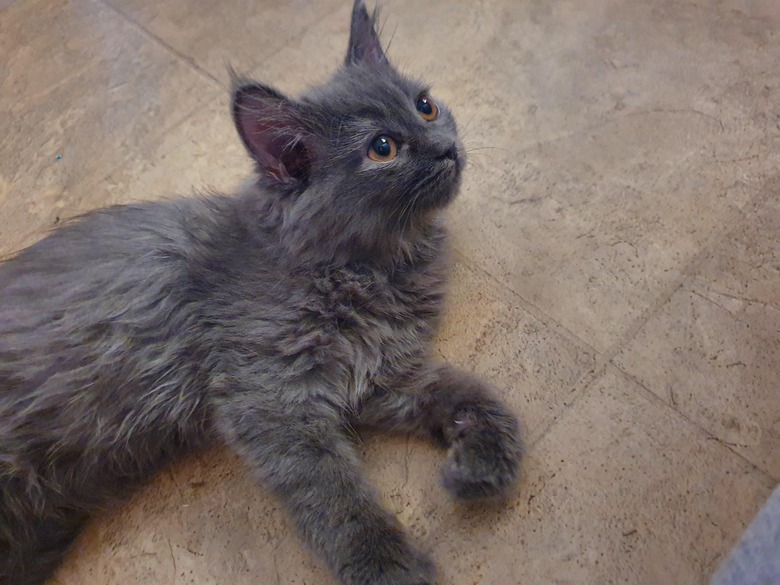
[360,364,521,500]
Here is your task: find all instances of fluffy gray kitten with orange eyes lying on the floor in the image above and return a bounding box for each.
[0,0,520,585]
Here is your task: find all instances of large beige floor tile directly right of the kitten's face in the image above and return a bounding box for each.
[438,2,780,351]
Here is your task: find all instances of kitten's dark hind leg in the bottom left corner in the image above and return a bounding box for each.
[0,422,200,585]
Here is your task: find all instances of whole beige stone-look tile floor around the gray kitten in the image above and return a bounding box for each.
[0,0,780,585]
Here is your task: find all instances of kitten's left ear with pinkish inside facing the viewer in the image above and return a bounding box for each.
[232,78,311,183]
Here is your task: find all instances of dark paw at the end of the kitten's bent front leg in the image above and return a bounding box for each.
[442,412,521,500]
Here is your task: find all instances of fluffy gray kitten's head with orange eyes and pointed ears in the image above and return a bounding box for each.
[233,0,465,262]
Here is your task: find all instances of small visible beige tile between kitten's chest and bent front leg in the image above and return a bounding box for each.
[438,263,595,444]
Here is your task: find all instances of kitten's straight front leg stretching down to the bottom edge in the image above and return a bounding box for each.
[216,393,435,585]
